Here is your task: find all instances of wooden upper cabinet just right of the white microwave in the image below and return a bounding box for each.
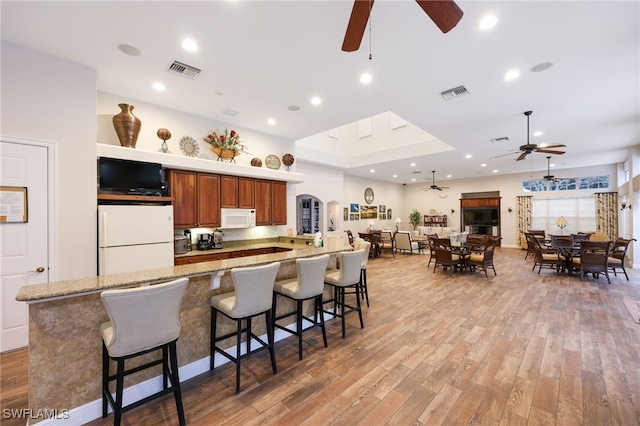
[255,179,287,226]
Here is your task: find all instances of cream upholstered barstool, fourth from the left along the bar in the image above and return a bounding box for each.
[324,250,364,338]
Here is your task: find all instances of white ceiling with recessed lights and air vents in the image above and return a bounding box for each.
[1,0,640,182]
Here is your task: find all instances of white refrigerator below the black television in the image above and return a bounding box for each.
[98,205,174,275]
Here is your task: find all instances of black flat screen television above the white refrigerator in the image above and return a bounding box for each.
[98,157,166,196]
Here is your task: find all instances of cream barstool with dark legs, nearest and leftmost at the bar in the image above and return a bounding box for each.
[100,278,189,426]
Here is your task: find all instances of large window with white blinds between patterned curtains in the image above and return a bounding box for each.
[531,197,596,235]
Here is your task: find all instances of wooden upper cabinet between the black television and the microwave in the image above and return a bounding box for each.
[169,170,220,228]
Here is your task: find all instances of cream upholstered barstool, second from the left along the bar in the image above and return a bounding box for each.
[210,262,280,393]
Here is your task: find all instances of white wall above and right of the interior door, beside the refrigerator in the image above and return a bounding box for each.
[0,41,97,280]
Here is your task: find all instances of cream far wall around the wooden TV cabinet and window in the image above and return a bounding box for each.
[402,164,618,247]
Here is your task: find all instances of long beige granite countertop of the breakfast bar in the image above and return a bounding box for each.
[16,239,351,303]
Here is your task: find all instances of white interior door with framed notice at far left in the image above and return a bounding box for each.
[0,140,49,352]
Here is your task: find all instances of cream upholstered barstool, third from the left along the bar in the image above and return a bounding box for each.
[273,254,329,360]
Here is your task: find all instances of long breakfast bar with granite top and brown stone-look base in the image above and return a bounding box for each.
[16,238,351,420]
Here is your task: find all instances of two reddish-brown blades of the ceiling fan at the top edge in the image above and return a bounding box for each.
[342,0,463,52]
